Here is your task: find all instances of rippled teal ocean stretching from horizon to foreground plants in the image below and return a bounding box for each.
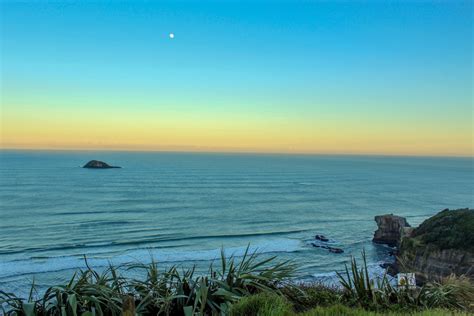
[0,150,474,294]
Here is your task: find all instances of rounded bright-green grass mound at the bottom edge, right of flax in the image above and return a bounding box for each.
[230,292,294,316]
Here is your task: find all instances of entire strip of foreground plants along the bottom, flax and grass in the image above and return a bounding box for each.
[0,248,474,316]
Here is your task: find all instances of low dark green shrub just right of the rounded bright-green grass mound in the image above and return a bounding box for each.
[281,282,342,312]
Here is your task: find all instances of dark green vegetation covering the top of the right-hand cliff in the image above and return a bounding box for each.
[412,209,474,251]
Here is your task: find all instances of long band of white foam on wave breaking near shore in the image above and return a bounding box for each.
[0,239,302,280]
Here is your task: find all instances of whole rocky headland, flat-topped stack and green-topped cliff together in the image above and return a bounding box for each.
[373,208,474,284]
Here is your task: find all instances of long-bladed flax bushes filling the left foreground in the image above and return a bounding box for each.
[0,247,295,316]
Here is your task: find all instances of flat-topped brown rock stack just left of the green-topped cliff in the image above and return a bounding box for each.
[372,214,410,247]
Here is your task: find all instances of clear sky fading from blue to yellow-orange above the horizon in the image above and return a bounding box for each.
[0,0,474,157]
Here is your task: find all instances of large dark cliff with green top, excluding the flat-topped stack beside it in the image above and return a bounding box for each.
[397,209,474,283]
